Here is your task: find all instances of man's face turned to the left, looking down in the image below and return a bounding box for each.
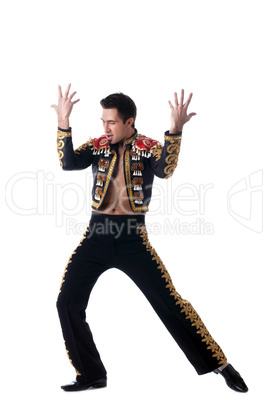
[101,109,133,144]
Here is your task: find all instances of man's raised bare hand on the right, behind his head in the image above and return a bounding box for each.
[168,89,196,134]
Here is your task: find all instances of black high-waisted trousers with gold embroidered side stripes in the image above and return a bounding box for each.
[57,212,226,381]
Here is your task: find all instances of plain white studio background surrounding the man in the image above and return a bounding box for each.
[0,0,268,402]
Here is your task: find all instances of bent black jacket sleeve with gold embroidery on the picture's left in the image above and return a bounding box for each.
[57,128,94,170]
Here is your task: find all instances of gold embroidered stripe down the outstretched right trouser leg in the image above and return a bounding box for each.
[138,226,227,365]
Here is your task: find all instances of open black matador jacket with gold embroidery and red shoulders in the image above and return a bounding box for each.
[57,128,182,213]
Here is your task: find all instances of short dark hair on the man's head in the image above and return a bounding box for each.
[100,92,137,127]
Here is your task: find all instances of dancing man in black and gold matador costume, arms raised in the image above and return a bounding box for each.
[52,84,248,392]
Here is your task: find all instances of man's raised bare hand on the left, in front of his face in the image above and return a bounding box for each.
[51,84,80,130]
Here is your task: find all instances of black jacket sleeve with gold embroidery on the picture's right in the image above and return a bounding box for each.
[149,131,182,179]
